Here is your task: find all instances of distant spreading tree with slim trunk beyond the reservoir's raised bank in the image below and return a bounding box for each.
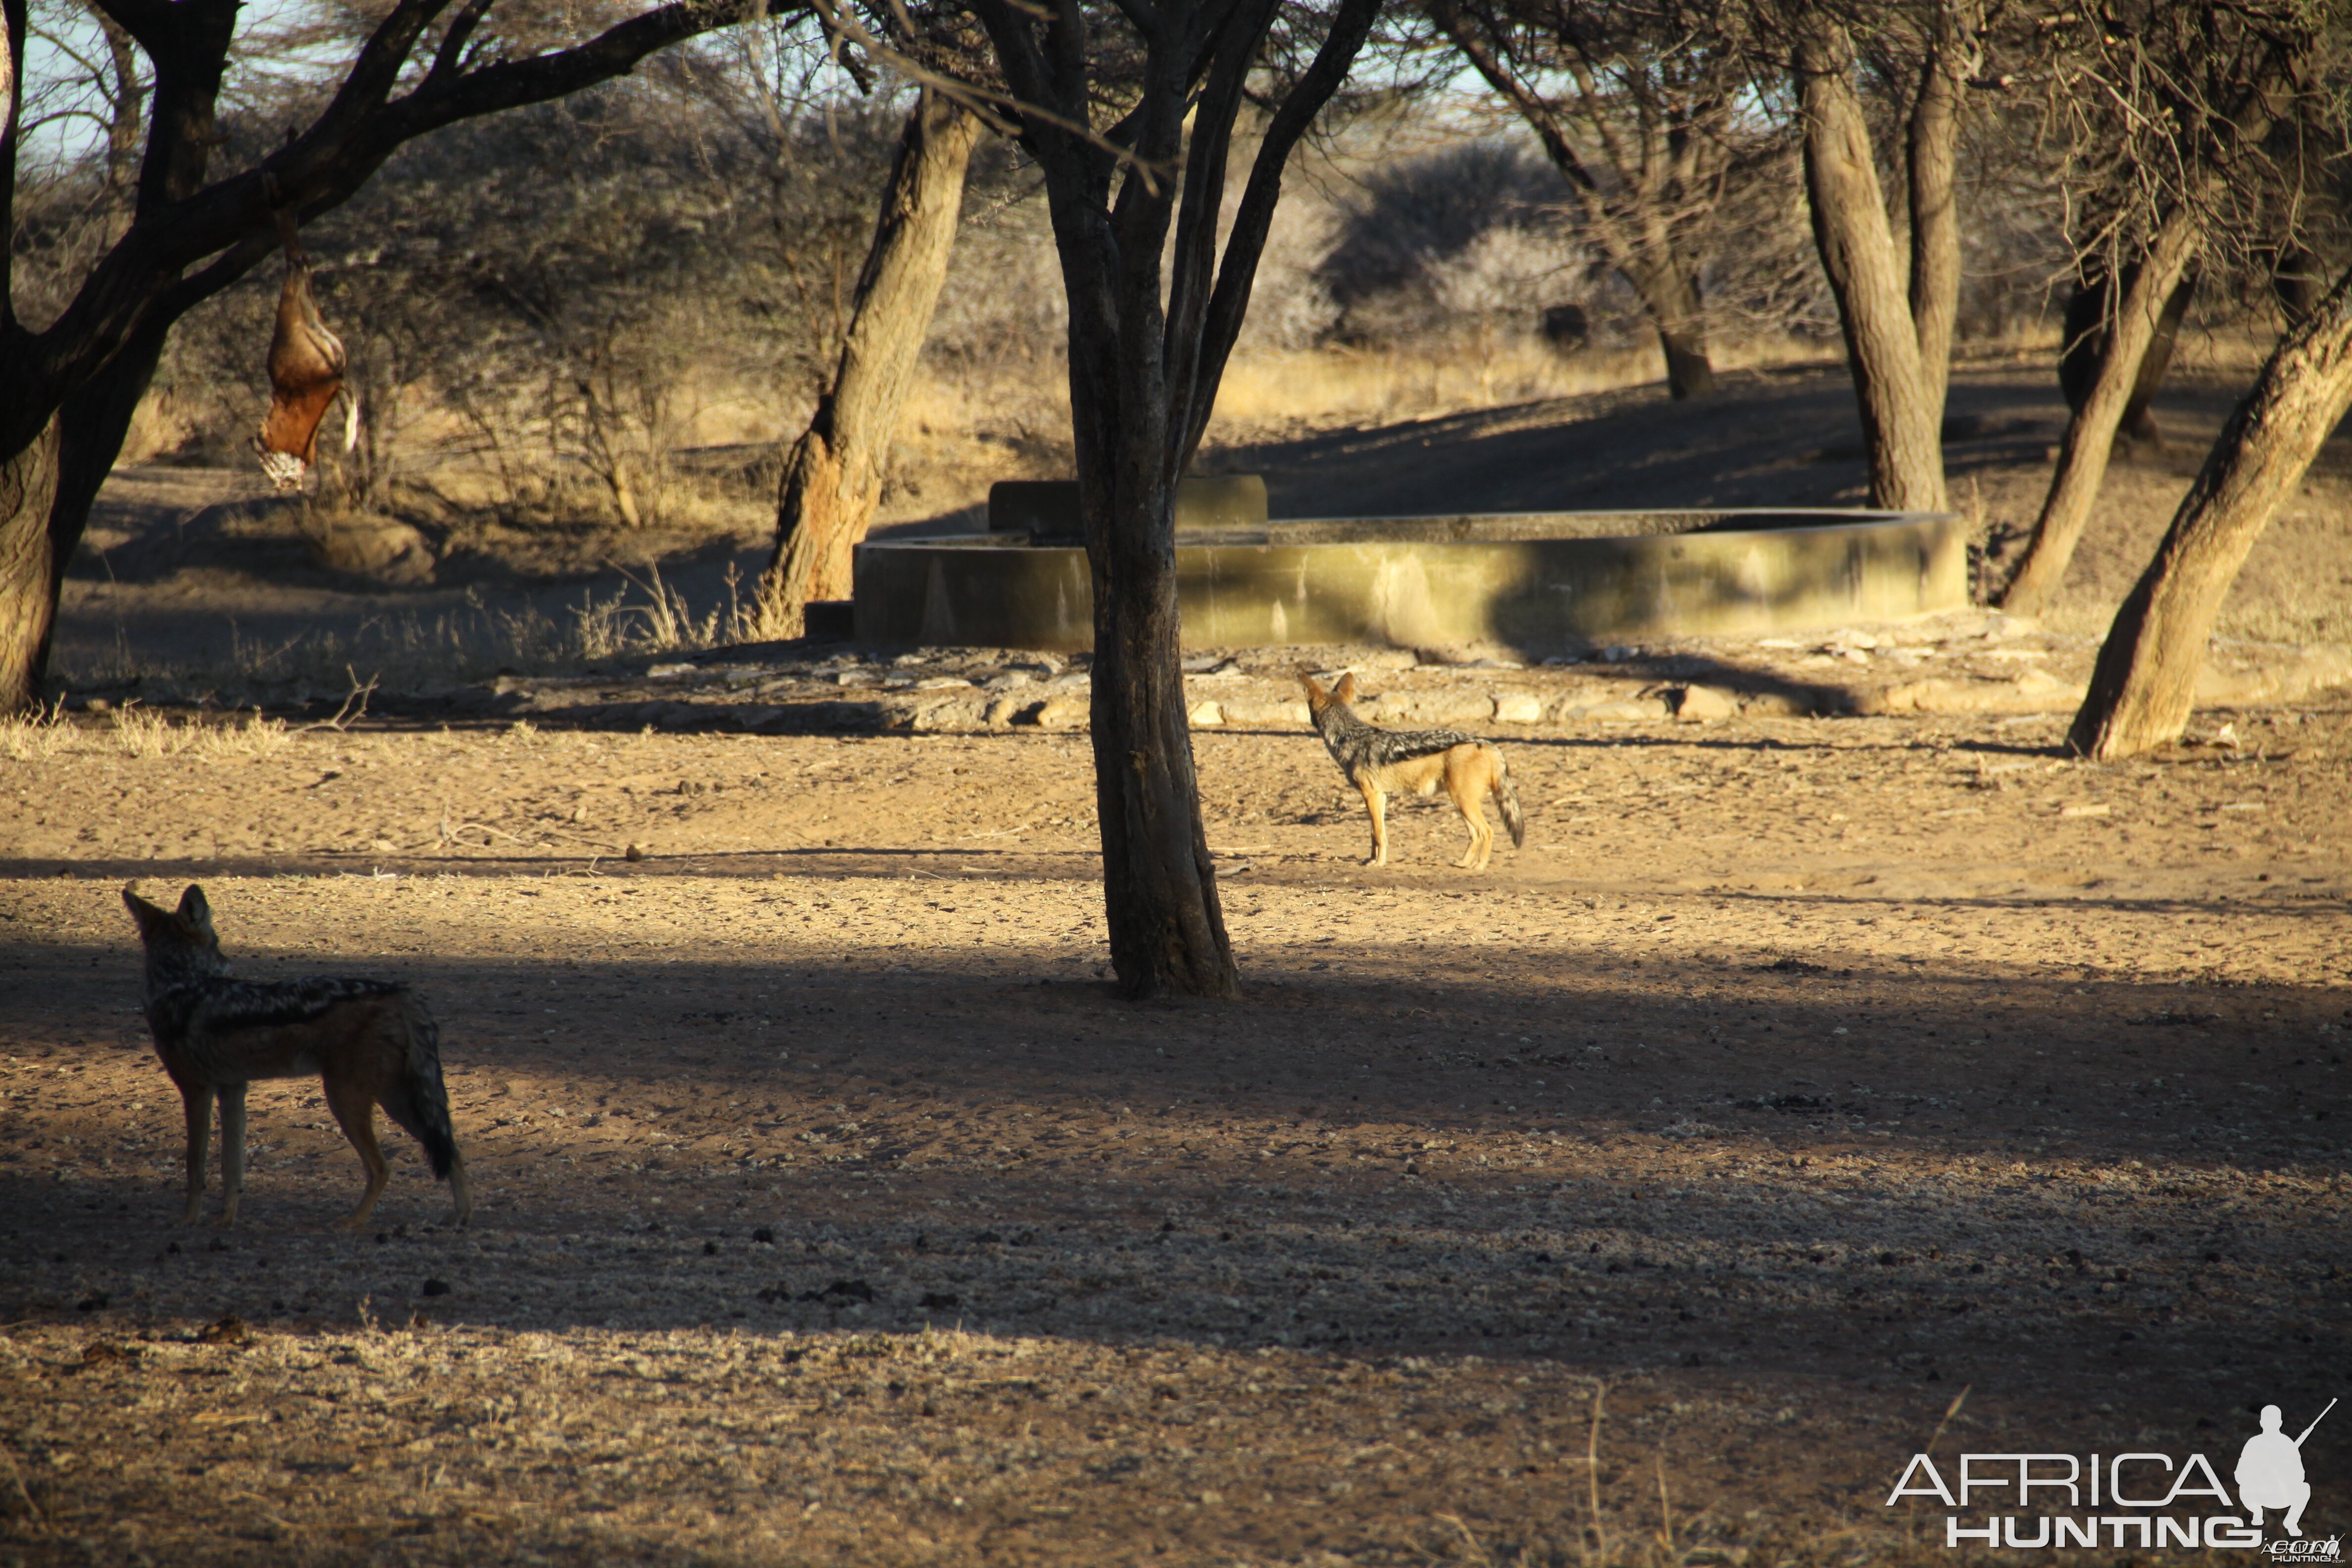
[1427,0,1748,397]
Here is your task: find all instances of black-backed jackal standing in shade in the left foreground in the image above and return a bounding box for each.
[122,884,473,1229]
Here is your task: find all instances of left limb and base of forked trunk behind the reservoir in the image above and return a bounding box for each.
[1797,23,1957,512]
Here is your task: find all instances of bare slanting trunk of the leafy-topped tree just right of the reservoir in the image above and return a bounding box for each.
[2002,202,2204,616]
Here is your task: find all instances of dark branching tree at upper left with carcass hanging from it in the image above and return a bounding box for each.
[0,0,769,712]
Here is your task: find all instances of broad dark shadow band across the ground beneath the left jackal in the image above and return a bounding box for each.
[0,921,2345,1420]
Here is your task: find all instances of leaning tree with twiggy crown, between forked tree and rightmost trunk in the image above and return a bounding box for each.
[2002,4,2319,616]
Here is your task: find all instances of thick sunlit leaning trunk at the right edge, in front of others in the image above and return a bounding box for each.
[2067,273,2352,762]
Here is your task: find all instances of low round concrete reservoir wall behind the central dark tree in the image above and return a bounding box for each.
[856,510,1968,656]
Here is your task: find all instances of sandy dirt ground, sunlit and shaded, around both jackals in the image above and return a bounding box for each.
[0,362,2352,1568]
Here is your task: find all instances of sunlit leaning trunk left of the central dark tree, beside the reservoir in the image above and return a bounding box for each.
[757,89,981,637]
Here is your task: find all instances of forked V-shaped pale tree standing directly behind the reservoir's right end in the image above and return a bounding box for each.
[1788,0,1980,512]
